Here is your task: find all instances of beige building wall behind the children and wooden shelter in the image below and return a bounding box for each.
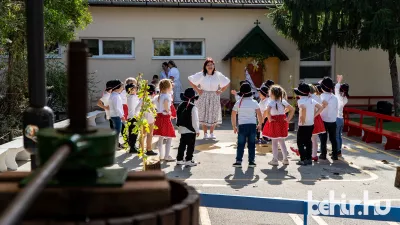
[78,7,400,97]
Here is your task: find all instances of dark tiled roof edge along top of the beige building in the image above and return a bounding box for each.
[89,1,276,9]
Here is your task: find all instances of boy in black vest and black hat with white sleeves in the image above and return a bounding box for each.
[176,88,200,166]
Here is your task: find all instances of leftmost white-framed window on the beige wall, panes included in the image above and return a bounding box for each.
[81,38,135,58]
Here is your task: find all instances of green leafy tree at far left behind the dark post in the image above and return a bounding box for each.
[0,0,91,133]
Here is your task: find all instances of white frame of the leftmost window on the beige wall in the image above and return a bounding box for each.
[79,37,135,59]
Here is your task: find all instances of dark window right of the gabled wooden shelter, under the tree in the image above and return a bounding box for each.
[300,47,335,83]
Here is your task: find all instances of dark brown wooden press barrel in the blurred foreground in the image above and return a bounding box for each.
[0,171,199,225]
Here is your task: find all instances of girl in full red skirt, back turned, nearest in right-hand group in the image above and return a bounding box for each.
[263,85,294,166]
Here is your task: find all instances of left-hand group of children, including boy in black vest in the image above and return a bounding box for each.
[97,77,199,166]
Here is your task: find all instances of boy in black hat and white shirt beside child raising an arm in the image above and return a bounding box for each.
[319,77,339,160]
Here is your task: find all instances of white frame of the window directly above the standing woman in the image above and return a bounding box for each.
[151,38,206,59]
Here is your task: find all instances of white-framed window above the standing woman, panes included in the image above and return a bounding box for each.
[153,39,205,59]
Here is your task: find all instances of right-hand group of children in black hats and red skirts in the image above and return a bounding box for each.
[231,75,349,167]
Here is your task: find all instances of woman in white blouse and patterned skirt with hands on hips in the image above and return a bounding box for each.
[189,58,230,139]
